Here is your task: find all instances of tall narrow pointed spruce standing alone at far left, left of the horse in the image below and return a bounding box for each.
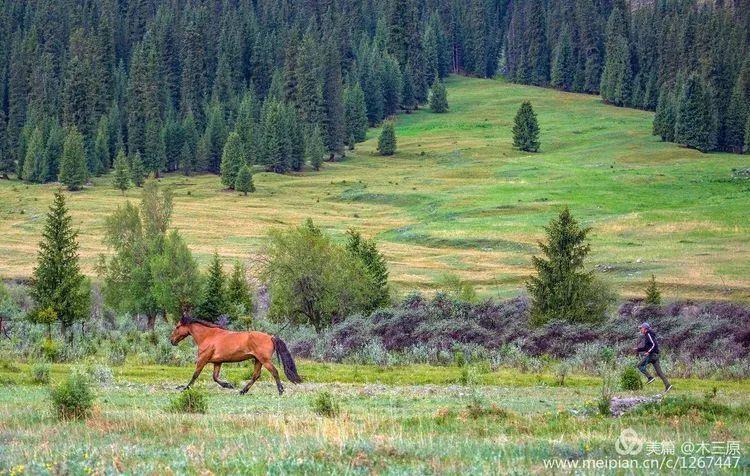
[31,189,90,329]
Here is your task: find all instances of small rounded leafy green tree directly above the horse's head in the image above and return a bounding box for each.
[150,230,200,319]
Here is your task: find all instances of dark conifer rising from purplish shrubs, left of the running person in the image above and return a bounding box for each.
[526,207,608,325]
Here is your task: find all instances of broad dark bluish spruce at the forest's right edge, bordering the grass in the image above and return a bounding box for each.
[675,74,716,152]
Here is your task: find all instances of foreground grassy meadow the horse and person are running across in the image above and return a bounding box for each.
[0,362,750,474]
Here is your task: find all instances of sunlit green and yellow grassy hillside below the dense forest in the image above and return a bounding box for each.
[0,78,750,300]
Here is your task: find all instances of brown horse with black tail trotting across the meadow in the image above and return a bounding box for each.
[169,317,302,395]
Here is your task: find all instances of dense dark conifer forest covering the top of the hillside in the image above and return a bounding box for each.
[0,0,750,182]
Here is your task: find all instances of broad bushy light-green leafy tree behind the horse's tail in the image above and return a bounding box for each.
[261,219,375,331]
